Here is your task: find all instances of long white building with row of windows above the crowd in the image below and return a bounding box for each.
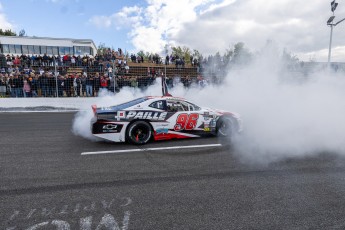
[0,36,97,56]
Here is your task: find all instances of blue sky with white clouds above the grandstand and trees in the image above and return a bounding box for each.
[0,0,345,62]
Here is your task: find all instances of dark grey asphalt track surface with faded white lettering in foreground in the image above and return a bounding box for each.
[0,113,345,230]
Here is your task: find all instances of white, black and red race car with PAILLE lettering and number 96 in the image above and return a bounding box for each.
[91,96,242,145]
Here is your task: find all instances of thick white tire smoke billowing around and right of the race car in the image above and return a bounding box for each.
[73,52,345,163]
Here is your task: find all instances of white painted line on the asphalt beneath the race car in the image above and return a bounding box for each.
[81,144,222,155]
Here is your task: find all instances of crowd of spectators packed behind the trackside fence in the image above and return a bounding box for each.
[0,49,207,97]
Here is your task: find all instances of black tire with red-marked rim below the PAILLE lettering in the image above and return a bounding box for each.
[126,121,153,145]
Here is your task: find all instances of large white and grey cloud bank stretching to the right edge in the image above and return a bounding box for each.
[90,0,345,61]
